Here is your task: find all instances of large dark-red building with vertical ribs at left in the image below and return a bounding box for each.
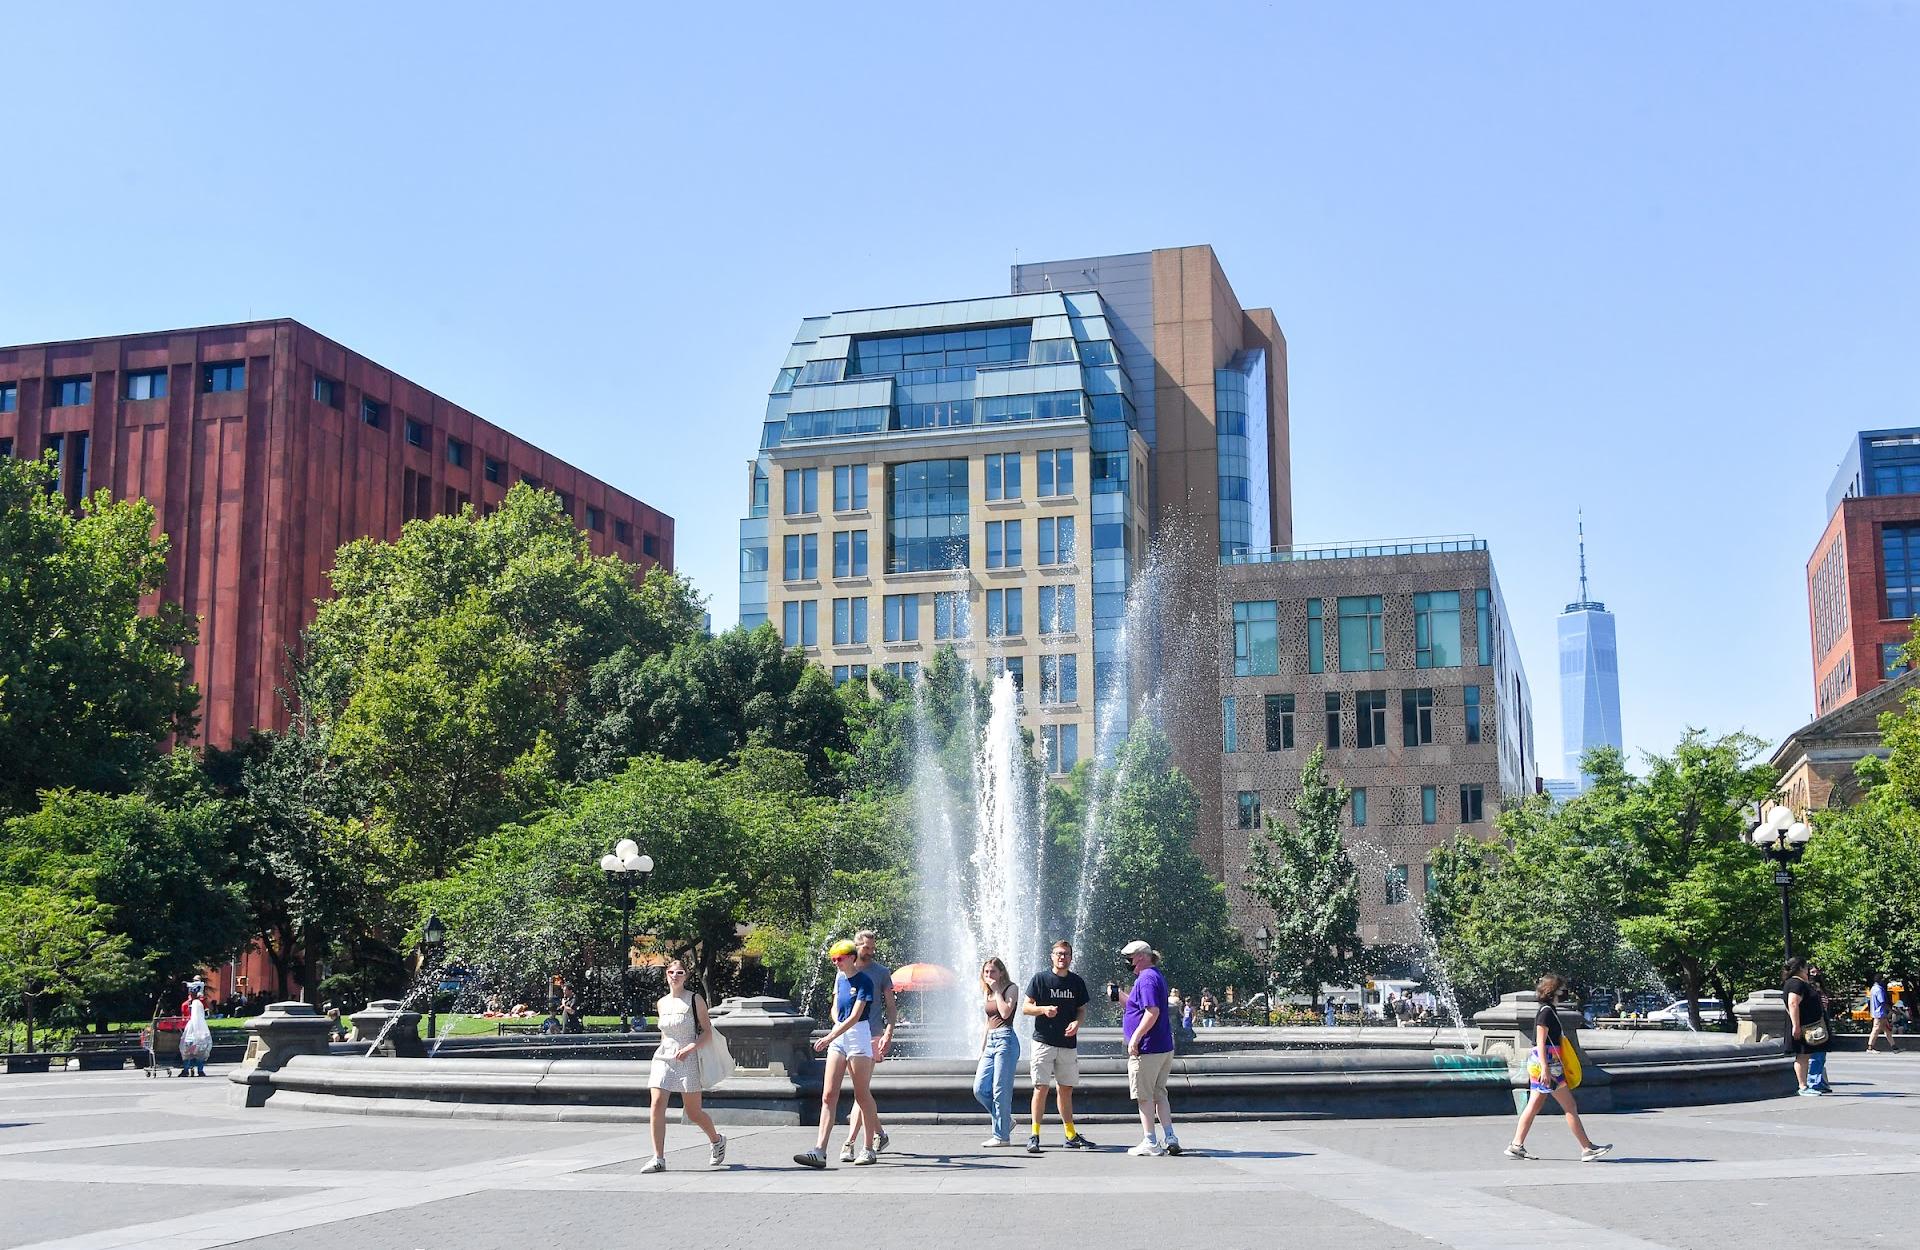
[0,321,674,745]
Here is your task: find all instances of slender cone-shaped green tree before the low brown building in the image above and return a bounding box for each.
[1246,747,1361,1008]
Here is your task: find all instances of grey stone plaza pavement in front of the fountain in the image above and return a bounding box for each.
[0,1054,1920,1250]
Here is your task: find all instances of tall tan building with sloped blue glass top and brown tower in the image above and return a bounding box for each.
[739,248,1292,791]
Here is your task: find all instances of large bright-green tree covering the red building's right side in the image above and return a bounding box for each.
[300,486,699,876]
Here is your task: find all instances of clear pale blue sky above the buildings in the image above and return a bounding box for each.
[0,0,1920,776]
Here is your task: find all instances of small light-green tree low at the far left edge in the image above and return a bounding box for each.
[0,885,146,1050]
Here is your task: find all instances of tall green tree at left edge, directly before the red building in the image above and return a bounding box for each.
[0,457,200,812]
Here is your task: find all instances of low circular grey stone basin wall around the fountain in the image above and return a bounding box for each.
[232,1029,1793,1125]
